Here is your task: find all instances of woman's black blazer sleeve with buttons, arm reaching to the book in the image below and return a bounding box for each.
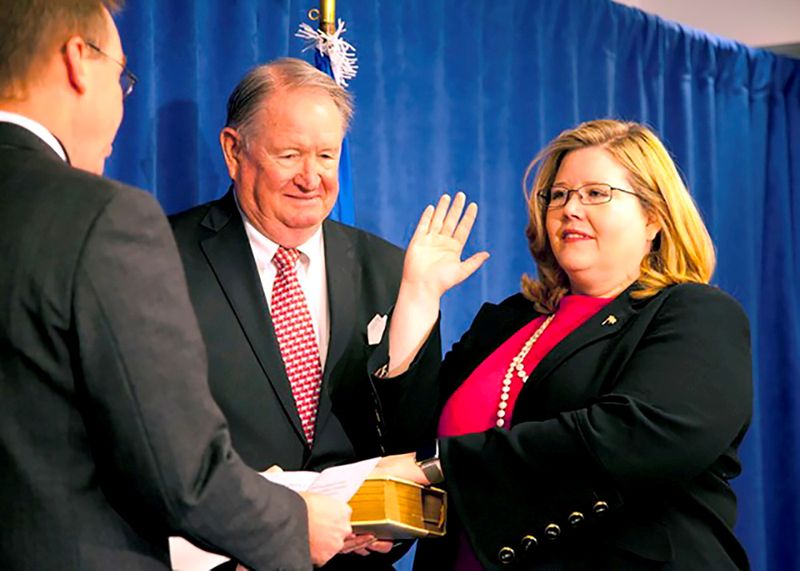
[441,285,752,565]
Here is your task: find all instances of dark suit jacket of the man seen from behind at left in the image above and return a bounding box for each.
[0,123,311,570]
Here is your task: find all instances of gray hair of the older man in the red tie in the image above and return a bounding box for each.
[225,58,353,140]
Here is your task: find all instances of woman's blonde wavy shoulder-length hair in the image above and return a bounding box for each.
[522,119,716,313]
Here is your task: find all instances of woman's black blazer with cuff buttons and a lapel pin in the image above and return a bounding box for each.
[417,284,752,570]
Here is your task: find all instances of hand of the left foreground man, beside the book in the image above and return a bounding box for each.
[300,492,353,566]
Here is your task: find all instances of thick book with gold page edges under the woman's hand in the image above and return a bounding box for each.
[349,476,447,539]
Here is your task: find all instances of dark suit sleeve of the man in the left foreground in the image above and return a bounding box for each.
[74,189,311,569]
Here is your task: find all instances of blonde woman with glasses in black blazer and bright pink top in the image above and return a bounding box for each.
[380,120,752,570]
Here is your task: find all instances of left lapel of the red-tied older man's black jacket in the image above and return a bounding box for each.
[200,190,306,442]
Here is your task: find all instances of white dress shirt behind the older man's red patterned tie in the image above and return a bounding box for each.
[234,203,330,371]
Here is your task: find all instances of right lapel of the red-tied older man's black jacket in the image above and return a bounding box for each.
[317,220,361,436]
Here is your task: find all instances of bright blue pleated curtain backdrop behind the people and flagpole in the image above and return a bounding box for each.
[108,0,800,570]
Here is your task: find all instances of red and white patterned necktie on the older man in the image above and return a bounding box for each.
[271,246,322,444]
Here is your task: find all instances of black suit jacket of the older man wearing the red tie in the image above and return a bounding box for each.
[170,191,441,568]
